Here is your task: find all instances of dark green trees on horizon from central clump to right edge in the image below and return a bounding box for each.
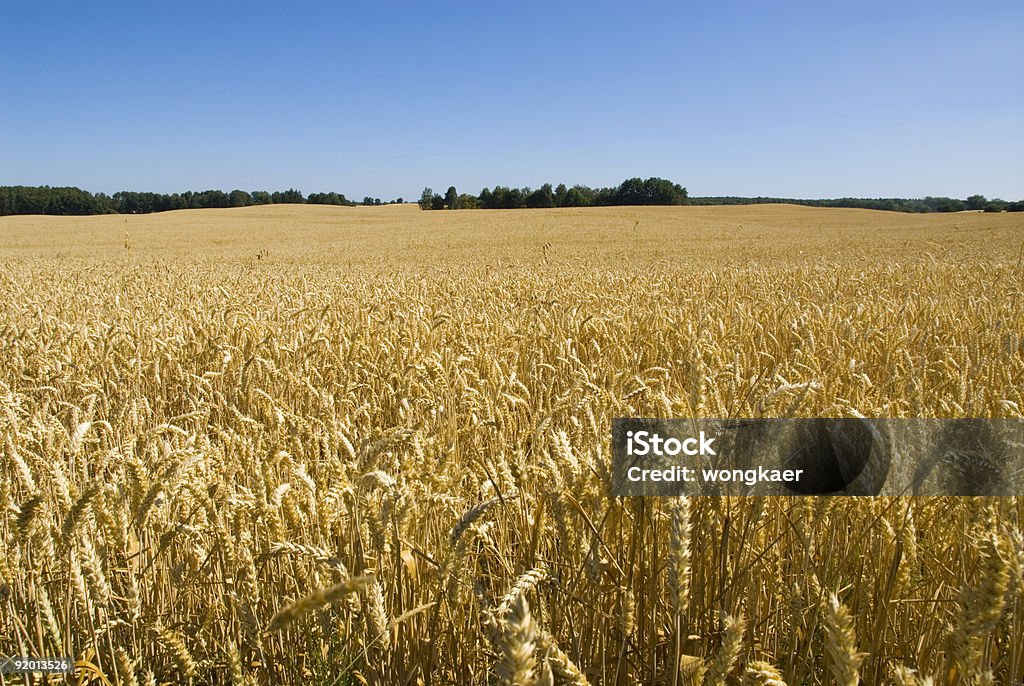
[419,177,1024,212]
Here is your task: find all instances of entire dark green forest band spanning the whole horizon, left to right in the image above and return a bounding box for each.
[0,177,1024,216]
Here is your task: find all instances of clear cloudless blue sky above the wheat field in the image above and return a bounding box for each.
[0,0,1024,200]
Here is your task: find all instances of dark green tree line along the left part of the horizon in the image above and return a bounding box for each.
[0,185,403,216]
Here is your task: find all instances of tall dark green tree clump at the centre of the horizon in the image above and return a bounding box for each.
[419,176,688,210]
